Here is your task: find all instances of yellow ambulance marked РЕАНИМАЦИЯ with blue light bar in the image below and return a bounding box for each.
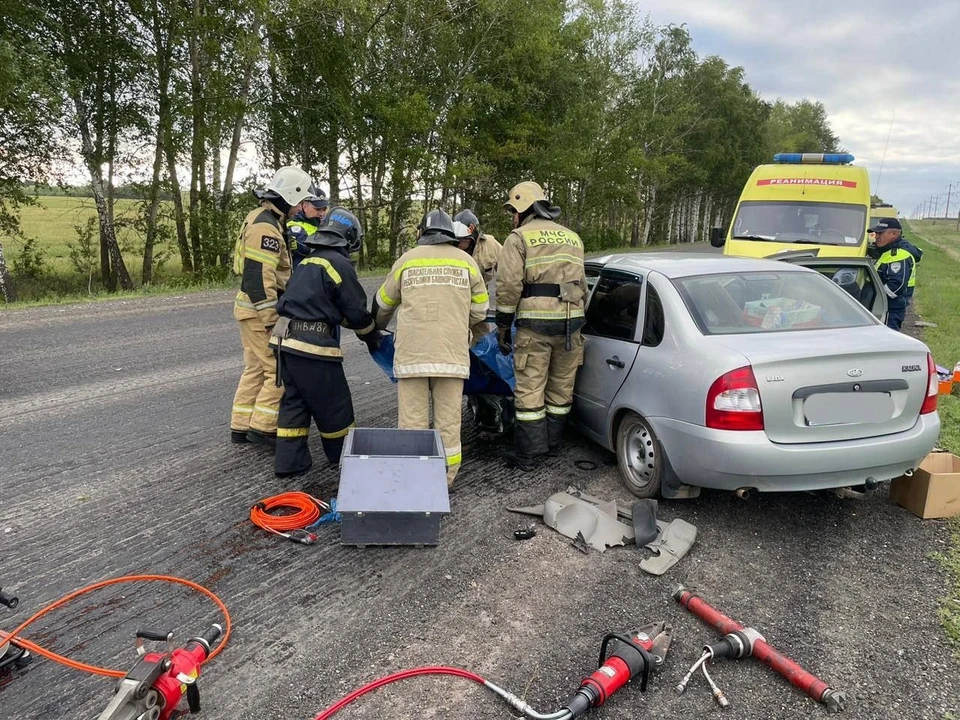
[710,153,871,257]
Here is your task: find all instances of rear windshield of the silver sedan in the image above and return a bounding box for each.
[673,270,876,335]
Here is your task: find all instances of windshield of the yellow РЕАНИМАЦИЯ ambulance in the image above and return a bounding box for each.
[731,200,867,246]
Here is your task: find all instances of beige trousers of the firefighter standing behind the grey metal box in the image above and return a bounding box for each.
[397,377,463,487]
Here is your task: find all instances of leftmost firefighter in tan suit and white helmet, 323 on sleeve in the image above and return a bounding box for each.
[230,166,318,447]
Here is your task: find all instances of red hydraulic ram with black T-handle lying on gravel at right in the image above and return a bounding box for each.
[673,585,846,712]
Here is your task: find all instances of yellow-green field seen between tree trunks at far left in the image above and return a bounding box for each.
[7,195,179,277]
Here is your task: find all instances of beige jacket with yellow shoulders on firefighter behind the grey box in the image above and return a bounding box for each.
[375,244,489,378]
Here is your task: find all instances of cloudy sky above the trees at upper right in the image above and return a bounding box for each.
[634,0,960,216]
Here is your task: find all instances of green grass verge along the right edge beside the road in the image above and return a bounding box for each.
[907,221,960,647]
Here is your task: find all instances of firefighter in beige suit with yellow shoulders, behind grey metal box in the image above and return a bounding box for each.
[374,210,489,487]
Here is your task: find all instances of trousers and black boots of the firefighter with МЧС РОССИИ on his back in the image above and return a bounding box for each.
[513,328,583,458]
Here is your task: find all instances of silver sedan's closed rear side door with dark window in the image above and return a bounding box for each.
[573,270,644,444]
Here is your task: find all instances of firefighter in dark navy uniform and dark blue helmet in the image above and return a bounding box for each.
[270,207,380,477]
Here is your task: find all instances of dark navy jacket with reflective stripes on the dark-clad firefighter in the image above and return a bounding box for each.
[270,247,374,361]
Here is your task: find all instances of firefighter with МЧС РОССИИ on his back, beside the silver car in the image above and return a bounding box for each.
[496,182,587,472]
